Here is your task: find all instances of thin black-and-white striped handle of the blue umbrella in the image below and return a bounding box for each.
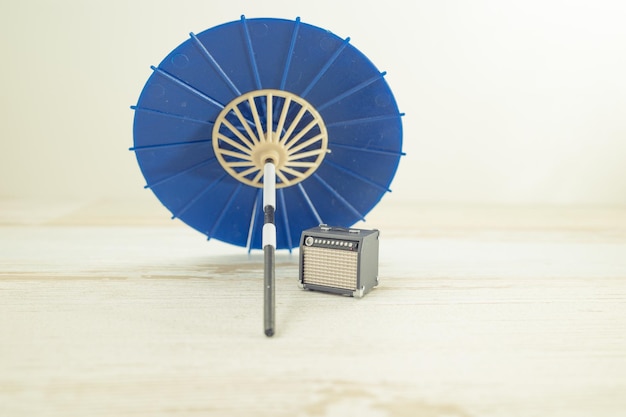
[263,160,276,337]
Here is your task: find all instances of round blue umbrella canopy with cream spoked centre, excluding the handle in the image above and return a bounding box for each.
[131,16,403,249]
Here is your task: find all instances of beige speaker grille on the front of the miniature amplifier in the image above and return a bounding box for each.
[302,246,358,290]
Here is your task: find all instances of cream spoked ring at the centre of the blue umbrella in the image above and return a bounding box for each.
[212,89,328,188]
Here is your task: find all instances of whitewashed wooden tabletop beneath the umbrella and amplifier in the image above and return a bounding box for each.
[0,200,626,417]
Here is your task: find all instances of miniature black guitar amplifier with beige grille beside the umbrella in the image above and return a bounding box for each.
[300,224,380,297]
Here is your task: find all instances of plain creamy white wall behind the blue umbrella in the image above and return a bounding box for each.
[0,0,626,205]
